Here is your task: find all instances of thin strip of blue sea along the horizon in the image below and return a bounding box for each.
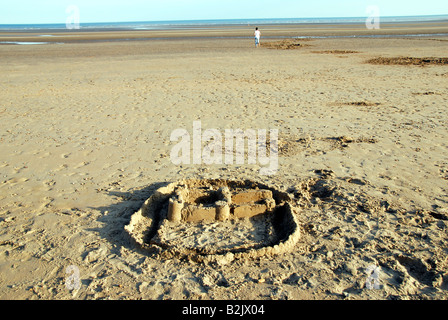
[0,14,448,31]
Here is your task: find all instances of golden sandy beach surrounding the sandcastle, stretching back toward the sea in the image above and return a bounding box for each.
[0,24,448,300]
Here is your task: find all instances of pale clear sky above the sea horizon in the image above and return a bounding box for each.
[0,0,448,24]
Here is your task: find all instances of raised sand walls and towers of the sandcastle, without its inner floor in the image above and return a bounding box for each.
[125,180,300,263]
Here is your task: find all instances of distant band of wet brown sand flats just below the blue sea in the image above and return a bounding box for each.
[0,22,448,44]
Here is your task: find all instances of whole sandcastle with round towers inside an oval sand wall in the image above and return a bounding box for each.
[125,179,300,262]
